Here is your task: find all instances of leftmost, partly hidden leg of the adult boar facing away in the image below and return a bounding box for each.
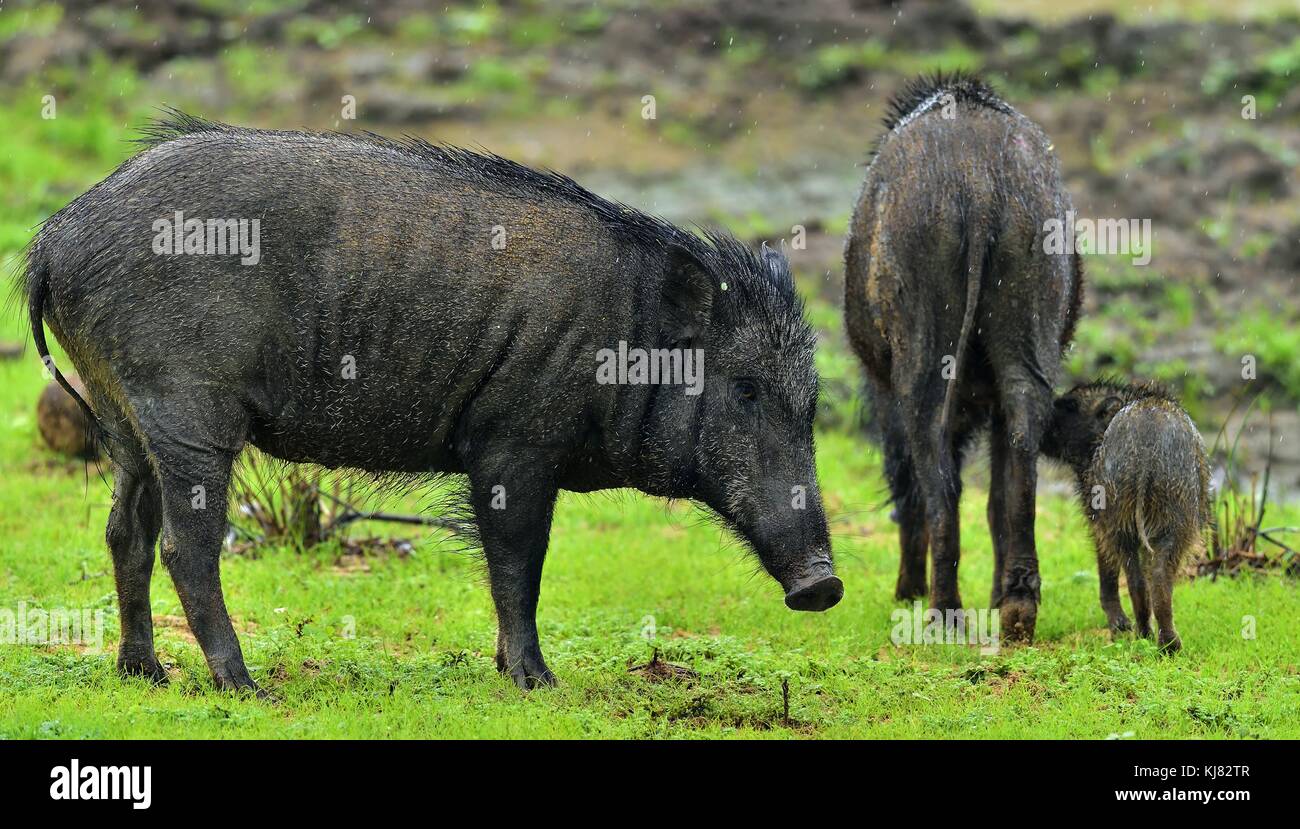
[876,395,930,600]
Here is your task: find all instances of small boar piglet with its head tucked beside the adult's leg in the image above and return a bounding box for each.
[1043,381,1210,652]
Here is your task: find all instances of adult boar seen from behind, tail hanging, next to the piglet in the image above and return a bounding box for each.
[845,75,1082,639]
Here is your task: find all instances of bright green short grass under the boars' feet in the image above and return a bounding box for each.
[0,296,1300,738]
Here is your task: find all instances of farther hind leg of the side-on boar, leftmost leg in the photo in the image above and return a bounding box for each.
[100,428,166,682]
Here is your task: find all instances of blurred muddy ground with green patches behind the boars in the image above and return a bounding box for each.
[0,0,1300,496]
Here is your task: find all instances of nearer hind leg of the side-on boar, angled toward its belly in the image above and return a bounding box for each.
[140,402,257,691]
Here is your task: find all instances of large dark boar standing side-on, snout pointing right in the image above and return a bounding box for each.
[25,113,842,689]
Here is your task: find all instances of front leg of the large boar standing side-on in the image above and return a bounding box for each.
[469,452,556,690]
